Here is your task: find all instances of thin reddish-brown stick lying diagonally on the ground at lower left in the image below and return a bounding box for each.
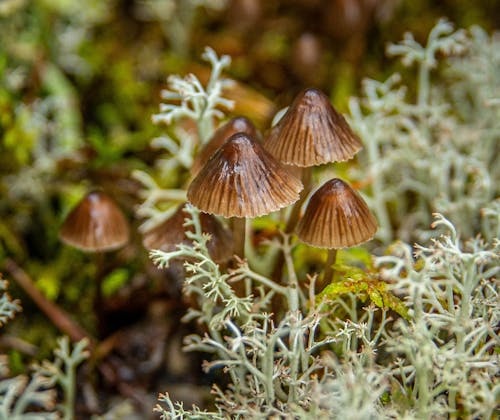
[5,259,94,347]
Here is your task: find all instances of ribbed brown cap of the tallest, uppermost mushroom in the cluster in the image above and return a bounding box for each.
[264,89,362,167]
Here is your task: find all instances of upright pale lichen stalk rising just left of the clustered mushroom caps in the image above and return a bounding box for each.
[132,48,233,230]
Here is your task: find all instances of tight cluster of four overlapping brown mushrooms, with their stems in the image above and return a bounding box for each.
[187,88,377,288]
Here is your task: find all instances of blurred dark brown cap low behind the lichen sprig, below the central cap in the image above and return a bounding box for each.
[142,204,234,263]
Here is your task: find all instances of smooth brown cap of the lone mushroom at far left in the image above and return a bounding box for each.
[59,191,130,252]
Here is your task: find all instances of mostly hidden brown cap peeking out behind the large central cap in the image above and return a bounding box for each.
[192,117,257,175]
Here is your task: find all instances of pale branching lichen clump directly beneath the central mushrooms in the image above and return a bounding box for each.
[151,206,342,418]
